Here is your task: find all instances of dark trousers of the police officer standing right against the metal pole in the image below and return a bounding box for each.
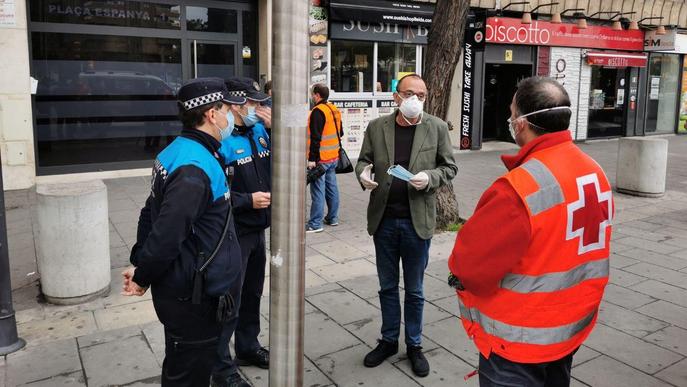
[212,230,267,380]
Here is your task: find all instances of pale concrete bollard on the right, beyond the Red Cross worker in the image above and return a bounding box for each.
[615,137,668,198]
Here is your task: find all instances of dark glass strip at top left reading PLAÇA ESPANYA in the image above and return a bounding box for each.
[27,0,181,30]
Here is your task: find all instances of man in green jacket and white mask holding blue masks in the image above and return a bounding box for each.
[355,74,458,376]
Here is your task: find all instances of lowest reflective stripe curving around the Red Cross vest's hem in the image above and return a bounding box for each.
[458,298,596,345]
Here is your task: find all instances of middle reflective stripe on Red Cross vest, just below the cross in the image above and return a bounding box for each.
[501,258,609,293]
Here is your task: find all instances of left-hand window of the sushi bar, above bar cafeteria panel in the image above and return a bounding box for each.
[331,40,374,93]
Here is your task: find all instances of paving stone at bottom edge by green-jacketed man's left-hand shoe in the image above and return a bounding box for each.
[315,345,418,387]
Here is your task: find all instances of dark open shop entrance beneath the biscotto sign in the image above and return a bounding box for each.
[482,64,532,142]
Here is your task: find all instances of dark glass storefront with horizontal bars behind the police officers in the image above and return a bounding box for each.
[27,0,259,174]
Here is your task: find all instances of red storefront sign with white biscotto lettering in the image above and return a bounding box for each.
[486,17,644,51]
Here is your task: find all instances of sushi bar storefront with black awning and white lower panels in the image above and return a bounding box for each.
[310,0,434,158]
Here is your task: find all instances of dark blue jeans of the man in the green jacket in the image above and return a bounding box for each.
[373,217,431,346]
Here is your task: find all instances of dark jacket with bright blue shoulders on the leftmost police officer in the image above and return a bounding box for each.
[130,130,241,298]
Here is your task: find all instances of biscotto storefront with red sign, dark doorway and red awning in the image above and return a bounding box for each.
[471,17,647,149]
